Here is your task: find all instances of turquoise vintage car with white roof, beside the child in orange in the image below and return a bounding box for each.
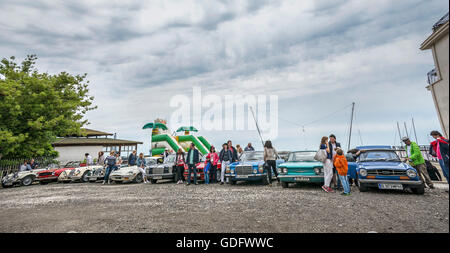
[278,151,324,188]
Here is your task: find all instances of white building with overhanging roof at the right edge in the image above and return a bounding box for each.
[420,13,449,138]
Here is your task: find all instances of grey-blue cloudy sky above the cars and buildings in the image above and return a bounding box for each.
[0,0,449,151]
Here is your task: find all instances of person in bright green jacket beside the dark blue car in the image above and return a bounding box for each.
[402,137,434,189]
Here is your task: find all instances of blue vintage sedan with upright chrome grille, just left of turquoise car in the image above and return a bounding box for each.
[225,151,284,185]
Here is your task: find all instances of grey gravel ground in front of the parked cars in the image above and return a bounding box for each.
[0,182,449,233]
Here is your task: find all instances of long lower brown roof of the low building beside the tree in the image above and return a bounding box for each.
[52,137,143,147]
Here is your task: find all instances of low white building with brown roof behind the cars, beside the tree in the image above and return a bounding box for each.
[52,128,142,164]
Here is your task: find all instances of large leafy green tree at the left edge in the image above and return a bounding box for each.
[0,55,96,158]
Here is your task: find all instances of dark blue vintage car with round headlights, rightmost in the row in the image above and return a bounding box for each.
[356,146,425,194]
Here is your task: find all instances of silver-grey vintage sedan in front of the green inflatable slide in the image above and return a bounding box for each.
[146,154,187,184]
